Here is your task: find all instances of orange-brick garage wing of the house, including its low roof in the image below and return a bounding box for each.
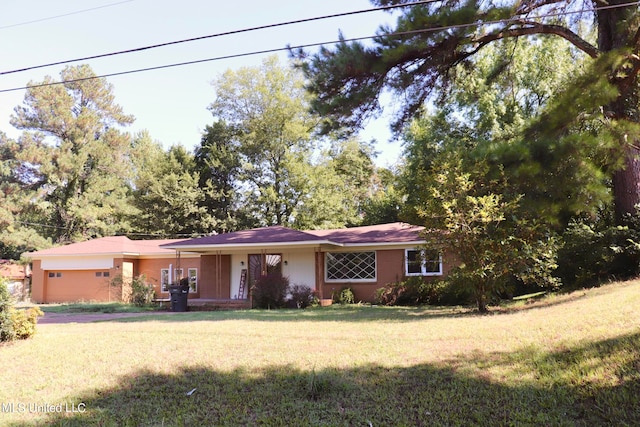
[23,236,200,303]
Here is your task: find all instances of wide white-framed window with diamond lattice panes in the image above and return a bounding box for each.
[325,252,376,282]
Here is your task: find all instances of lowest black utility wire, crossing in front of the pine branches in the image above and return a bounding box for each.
[0,0,639,93]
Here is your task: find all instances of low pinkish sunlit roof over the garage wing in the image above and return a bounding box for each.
[24,236,180,259]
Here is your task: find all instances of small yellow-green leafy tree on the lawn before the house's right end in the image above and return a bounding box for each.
[418,152,558,313]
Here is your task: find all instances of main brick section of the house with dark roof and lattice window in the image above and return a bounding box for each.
[162,223,451,301]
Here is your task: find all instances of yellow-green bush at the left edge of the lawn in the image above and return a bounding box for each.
[0,278,44,342]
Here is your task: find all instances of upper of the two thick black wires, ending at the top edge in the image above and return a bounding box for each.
[0,0,441,75]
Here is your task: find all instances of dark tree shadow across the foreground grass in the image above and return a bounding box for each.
[11,333,640,427]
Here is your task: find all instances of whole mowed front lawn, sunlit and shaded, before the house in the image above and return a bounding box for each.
[0,281,640,426]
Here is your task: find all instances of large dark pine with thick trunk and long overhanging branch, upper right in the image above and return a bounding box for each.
[299,0,640,224]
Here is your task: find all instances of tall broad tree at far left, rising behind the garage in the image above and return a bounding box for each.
[11,65,138,244]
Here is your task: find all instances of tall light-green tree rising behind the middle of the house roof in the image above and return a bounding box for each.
[209,56,316,225]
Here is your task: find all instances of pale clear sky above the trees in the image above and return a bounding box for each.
[0,0,401,166]
